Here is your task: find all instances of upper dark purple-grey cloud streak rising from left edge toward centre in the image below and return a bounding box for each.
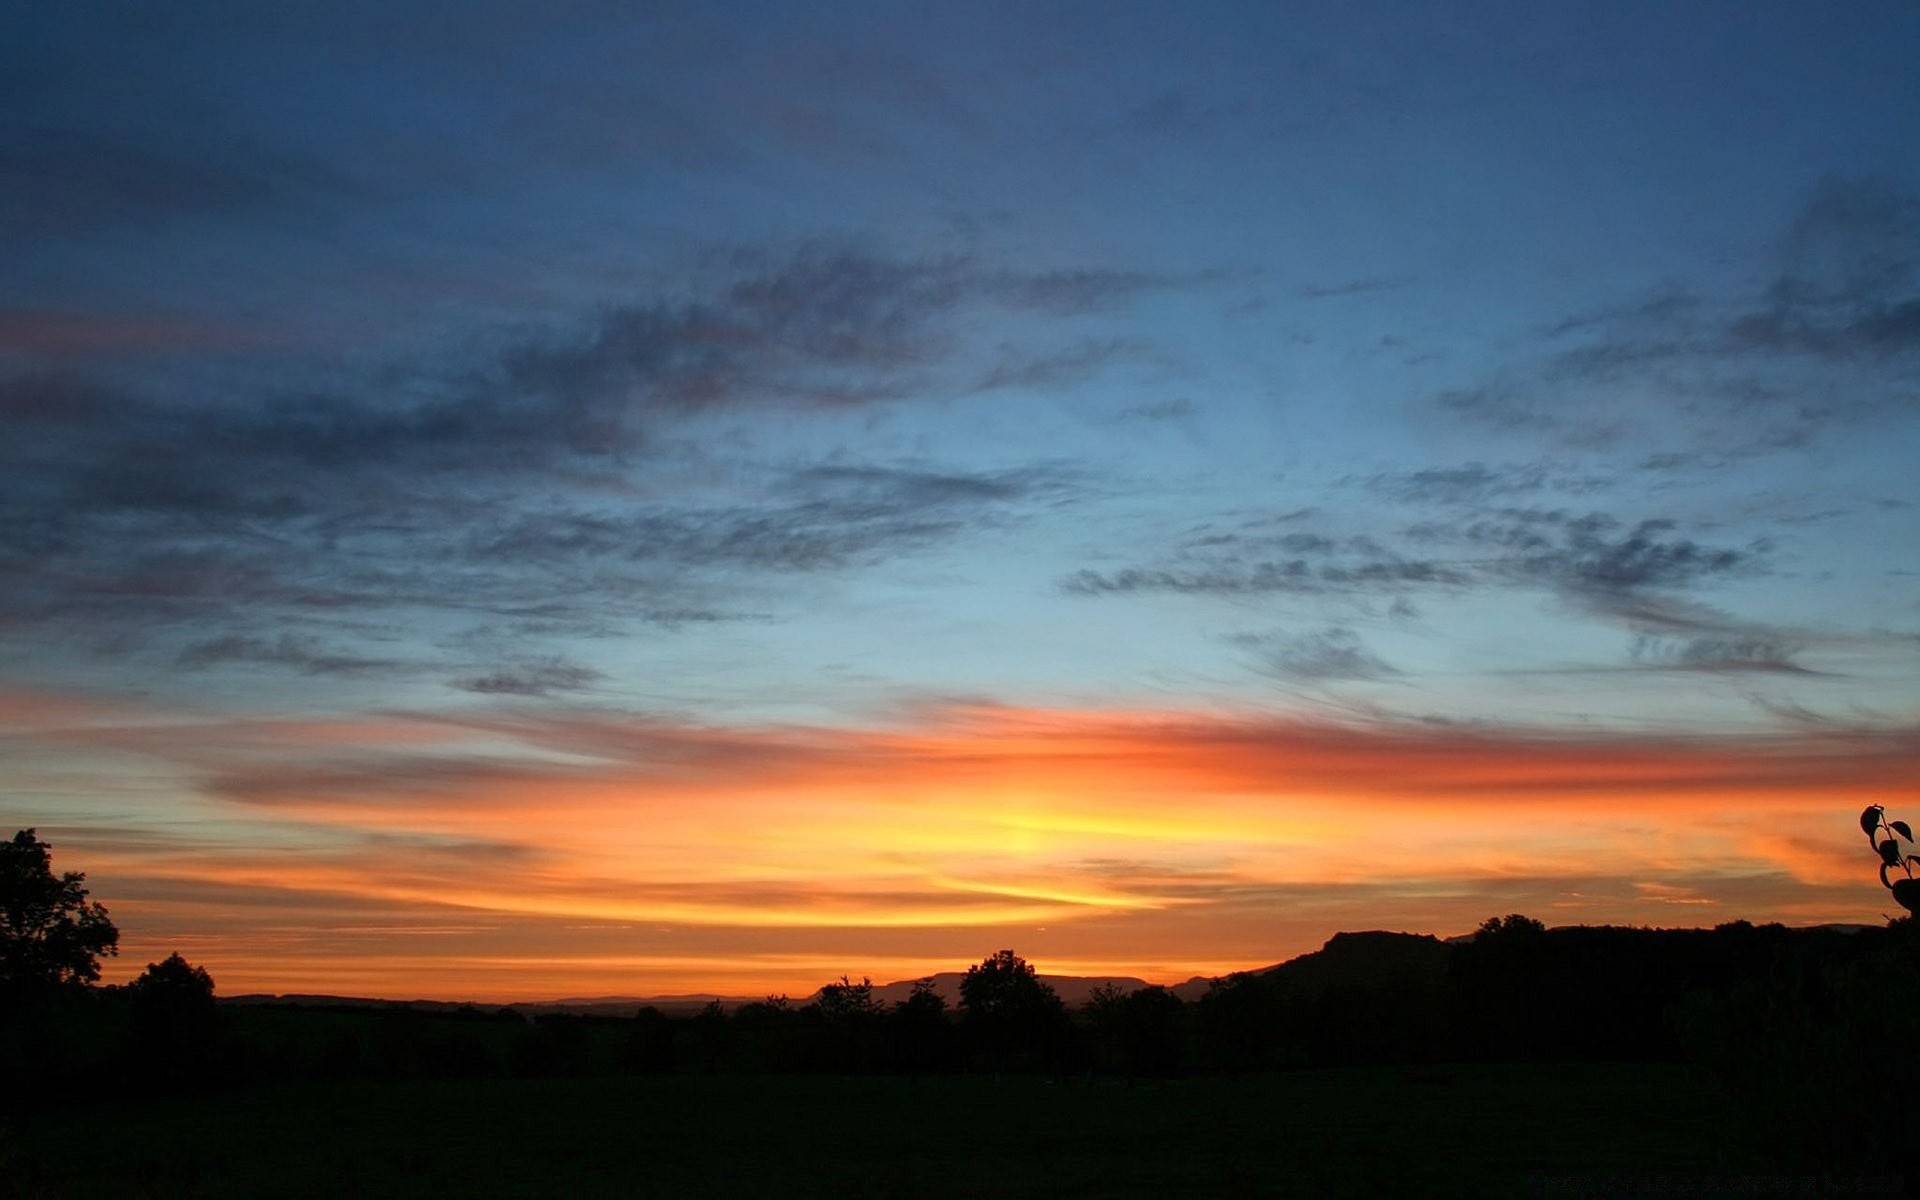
[0,248,1171,538]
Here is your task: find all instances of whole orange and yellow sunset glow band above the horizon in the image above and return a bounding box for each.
[11,697,1920,1000]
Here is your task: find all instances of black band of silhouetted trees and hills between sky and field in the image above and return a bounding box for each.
[11,829,1920,1154]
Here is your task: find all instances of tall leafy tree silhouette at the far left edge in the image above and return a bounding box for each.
[0,829,119,998]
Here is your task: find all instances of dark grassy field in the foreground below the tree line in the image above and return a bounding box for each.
[0,1064,1880,1200]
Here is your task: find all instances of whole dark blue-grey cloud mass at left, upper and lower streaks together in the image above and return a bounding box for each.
[0,246,1175,675]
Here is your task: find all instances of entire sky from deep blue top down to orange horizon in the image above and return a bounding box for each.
[0,0,1920,1000]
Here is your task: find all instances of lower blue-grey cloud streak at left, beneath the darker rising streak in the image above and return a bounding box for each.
[0,445,1077,683]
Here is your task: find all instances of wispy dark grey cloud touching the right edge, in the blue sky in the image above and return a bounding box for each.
[1432,177,1920,459]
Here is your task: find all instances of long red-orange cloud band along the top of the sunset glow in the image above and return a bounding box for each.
[48,691,1920,814]
